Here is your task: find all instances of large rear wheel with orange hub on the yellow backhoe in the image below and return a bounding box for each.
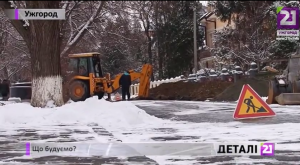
[69,80,90,102]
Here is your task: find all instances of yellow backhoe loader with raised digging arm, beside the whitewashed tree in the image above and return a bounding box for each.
[69,52,152,102]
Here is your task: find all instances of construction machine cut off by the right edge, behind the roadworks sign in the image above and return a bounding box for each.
[267,50,300,105]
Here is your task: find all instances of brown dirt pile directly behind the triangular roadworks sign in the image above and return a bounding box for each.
[214,78,269,101]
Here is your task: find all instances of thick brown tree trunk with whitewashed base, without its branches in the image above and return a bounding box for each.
[27,1,64,107]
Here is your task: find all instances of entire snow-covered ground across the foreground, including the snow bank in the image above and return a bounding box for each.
[0,98,300,165]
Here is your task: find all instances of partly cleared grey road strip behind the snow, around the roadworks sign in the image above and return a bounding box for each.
[134,101,300,124]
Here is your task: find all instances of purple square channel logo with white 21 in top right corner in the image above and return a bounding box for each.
[276,7,299,30]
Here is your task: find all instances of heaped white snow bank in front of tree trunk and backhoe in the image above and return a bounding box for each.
[0,97,162,128]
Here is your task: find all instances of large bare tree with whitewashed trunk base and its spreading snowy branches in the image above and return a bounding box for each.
[0,1,105,107]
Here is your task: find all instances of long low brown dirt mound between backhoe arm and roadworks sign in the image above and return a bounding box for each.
[144,80,232,101]
